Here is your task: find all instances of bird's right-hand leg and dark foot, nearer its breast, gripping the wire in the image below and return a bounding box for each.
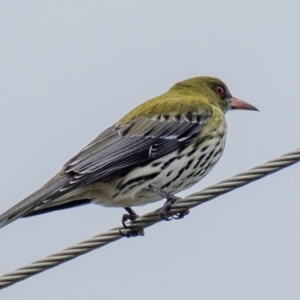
[149,185,190,221]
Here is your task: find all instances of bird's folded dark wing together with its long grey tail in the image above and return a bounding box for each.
[0,112,211,228]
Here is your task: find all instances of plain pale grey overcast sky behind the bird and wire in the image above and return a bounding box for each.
[0,0,300,300]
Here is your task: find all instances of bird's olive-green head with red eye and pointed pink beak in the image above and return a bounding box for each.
[172,76,258,113]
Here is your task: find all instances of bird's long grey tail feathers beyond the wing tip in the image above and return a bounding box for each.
[0,174,70,228]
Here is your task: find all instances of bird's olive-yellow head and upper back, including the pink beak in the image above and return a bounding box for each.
[119,76,258,123]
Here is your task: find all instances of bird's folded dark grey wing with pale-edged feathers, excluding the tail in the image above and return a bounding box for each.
[56,112,211,190]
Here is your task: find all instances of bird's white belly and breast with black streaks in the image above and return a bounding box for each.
[104,136,225,206]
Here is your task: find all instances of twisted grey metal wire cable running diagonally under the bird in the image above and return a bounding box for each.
[0,148,300,289]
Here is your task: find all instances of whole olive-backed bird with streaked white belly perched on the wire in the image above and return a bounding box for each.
[0,76,258,234]
